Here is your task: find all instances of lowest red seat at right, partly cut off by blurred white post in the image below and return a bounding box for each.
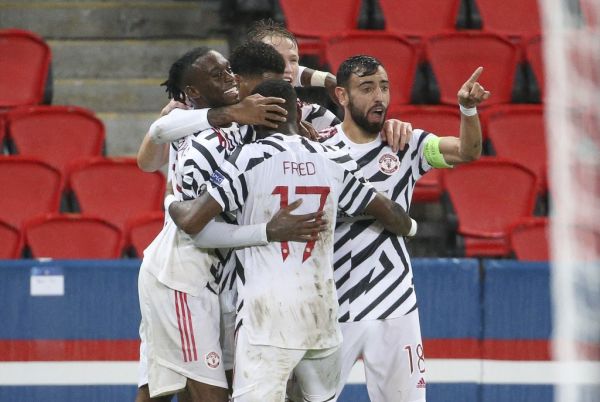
[509,217,550,261]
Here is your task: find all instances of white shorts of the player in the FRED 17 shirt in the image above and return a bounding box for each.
[233,326,340,402]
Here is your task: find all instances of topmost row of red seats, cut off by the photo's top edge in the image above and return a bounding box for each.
[279,0,548,40]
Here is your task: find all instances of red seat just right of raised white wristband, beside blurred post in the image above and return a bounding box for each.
[483,105,548,192]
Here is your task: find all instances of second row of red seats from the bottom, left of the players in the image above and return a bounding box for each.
[0,156,165,230]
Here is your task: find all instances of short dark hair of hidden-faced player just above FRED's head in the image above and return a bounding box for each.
[229,41,285,76]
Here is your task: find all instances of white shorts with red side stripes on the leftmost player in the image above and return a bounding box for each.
[138,267,227,398]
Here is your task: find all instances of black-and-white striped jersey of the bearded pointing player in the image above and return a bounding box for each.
[324,125,432,322]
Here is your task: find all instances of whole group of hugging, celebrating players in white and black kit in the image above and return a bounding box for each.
[131,21,490,402]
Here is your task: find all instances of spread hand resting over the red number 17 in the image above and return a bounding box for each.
[267,199,328,242]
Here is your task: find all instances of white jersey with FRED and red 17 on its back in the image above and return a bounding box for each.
[208,134,375,349]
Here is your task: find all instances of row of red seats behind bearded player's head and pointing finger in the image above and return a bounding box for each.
[320,31,544,105]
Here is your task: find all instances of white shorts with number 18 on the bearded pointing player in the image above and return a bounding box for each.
[337,310,426,402]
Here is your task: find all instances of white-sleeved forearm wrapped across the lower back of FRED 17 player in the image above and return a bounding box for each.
[194,220,268,248]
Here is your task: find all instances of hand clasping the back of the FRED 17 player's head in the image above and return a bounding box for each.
[230,94,287,128]
